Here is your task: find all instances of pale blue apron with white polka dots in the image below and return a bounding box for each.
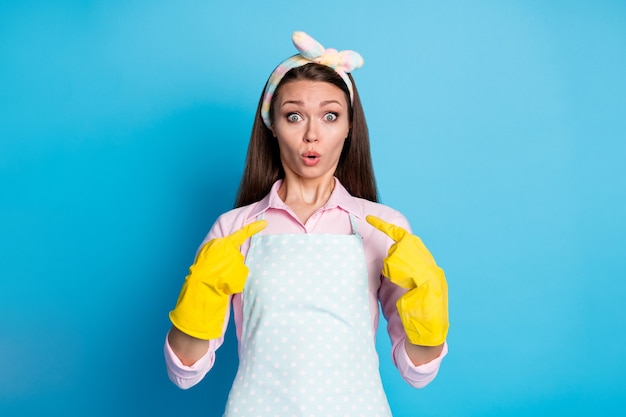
[224,215,391,417]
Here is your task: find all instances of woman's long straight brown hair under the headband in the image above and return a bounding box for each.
[235,63,378,207]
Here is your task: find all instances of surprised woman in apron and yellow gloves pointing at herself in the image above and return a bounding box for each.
[165,32,448,417]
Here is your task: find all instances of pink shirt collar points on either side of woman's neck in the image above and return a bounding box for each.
[243,178,364,220]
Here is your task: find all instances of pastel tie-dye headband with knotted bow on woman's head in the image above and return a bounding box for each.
[261,32,363,128]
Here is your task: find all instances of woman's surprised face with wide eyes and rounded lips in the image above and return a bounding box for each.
[272,80,350,183]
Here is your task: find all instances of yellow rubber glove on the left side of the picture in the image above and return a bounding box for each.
[170,220,267,340]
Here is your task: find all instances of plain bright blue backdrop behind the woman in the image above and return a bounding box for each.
[0,0,626,416]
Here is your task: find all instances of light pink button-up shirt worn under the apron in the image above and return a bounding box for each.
[165,180,448,389]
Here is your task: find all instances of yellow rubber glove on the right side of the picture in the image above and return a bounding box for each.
[366,216,449,346]
